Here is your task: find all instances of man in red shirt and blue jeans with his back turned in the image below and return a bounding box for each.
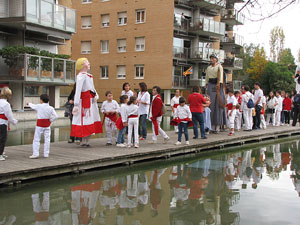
[188,86,207,139]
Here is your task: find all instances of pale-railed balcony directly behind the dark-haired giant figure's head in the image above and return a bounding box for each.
[190,47,225,63]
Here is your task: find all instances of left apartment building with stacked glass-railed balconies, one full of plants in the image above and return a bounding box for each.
[0,0,76,110]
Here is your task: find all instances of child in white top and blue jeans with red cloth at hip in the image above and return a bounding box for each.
[116,95,128,148]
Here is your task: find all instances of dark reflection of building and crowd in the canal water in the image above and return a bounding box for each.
[0,141,300,225]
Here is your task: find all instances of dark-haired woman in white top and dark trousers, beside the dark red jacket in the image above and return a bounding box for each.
[137,82,150,140]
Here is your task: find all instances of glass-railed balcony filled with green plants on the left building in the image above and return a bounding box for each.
[0,54,76,85]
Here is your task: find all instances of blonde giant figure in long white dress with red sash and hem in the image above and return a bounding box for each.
[71,58,102,147]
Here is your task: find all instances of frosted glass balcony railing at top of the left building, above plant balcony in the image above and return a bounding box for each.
[0,0,76,33]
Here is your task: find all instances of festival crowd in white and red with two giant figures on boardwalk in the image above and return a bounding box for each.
[0,54,300,160]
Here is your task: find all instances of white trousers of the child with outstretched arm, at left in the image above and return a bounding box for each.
[32,127,51,157]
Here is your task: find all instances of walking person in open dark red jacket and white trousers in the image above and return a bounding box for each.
[149,86,170,143]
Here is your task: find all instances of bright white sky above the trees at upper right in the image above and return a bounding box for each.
[235,0,300,61]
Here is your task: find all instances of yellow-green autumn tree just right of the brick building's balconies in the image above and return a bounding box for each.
[246,47,268,81]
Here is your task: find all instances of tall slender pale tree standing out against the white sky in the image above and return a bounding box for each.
[270,27,285,62]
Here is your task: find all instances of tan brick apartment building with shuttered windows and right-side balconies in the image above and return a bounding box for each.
[72,0,244,103]
